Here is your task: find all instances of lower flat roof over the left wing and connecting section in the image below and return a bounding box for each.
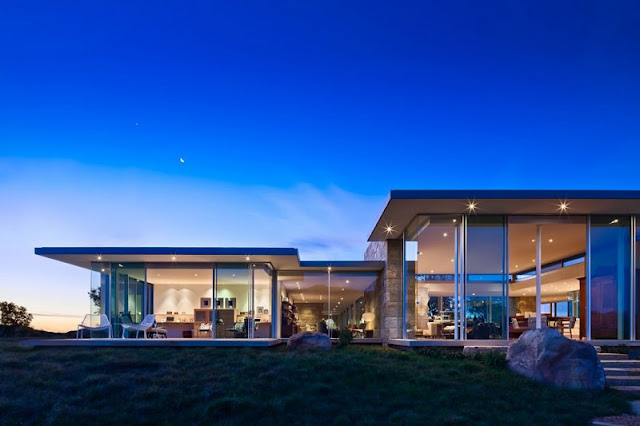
[35,247,384,271]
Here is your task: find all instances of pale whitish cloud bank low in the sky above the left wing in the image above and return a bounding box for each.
[0,158,383,328]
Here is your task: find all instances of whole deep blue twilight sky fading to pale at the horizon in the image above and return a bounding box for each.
[0,0,640,329]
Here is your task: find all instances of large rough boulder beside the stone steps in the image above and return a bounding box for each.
[507,328,604,390]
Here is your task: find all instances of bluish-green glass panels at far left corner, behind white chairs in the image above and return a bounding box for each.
[110,263,145,336]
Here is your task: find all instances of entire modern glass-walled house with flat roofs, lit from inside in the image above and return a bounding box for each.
[35,190,640,345]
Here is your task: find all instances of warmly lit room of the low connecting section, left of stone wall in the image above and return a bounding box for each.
[278,271,380,338]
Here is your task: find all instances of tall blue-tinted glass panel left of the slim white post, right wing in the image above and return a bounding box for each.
[465,216,507,339]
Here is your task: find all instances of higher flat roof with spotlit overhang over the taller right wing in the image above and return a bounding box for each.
[369,189,640,241]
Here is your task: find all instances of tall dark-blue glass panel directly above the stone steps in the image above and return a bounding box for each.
[590,216,631,340]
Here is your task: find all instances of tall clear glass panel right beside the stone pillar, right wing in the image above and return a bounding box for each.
[405,215,461,339]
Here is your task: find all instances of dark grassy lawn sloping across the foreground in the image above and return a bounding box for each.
[0,342,628,426]
